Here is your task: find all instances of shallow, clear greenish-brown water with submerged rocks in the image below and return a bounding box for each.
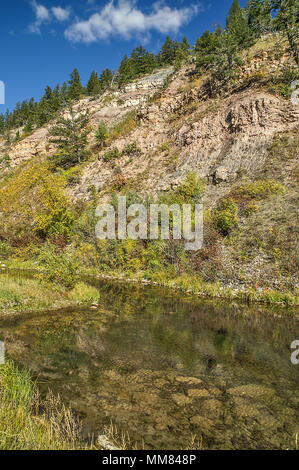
[0,282,299,449]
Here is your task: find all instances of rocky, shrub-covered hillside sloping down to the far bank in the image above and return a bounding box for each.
[0,37,299,303]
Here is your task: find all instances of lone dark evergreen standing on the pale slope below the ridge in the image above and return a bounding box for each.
[49,106,91,169]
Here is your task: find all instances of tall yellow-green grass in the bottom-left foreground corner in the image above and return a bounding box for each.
[0,361,93,450]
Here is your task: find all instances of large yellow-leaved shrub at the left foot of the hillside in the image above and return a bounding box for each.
[0,163,74,244]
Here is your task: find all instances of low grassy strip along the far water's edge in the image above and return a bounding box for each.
[0,261,299,314]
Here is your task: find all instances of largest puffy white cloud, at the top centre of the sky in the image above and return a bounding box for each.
[65,0,203,43]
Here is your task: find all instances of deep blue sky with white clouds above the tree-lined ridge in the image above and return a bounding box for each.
[0,0,246,113]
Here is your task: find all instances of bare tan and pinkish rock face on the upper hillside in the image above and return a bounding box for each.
[0,54,299,204]
